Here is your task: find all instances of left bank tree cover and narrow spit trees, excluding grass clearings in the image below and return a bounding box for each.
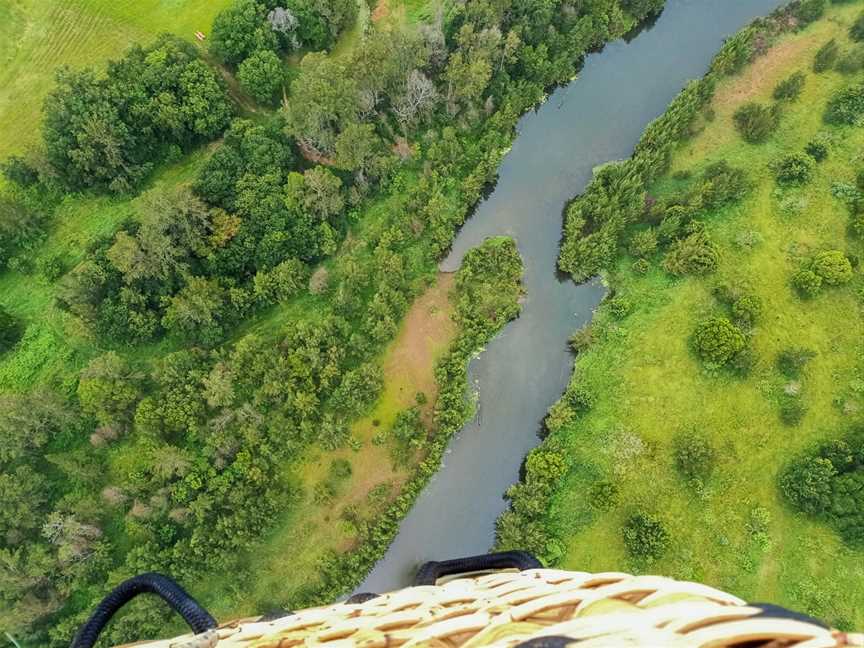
[0,0,680,645]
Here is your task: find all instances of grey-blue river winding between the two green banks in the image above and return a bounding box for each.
[357,0,783,592]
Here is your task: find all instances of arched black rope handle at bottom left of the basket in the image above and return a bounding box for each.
[70,573,217,648]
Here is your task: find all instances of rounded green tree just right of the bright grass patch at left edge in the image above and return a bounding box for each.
[78,351,141,425]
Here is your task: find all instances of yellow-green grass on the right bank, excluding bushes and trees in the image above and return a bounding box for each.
[553,5,864,627]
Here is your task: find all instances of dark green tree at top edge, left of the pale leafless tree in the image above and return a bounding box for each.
[210,0,278,66]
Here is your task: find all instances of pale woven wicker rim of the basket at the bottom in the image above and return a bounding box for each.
[120,569,864,648]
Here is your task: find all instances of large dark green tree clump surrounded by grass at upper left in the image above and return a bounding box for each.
[42,35,232,191]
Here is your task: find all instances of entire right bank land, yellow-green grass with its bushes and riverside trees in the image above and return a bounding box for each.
[497,0,864,629]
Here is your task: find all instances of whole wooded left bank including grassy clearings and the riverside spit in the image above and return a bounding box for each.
[0,0,668,646]
